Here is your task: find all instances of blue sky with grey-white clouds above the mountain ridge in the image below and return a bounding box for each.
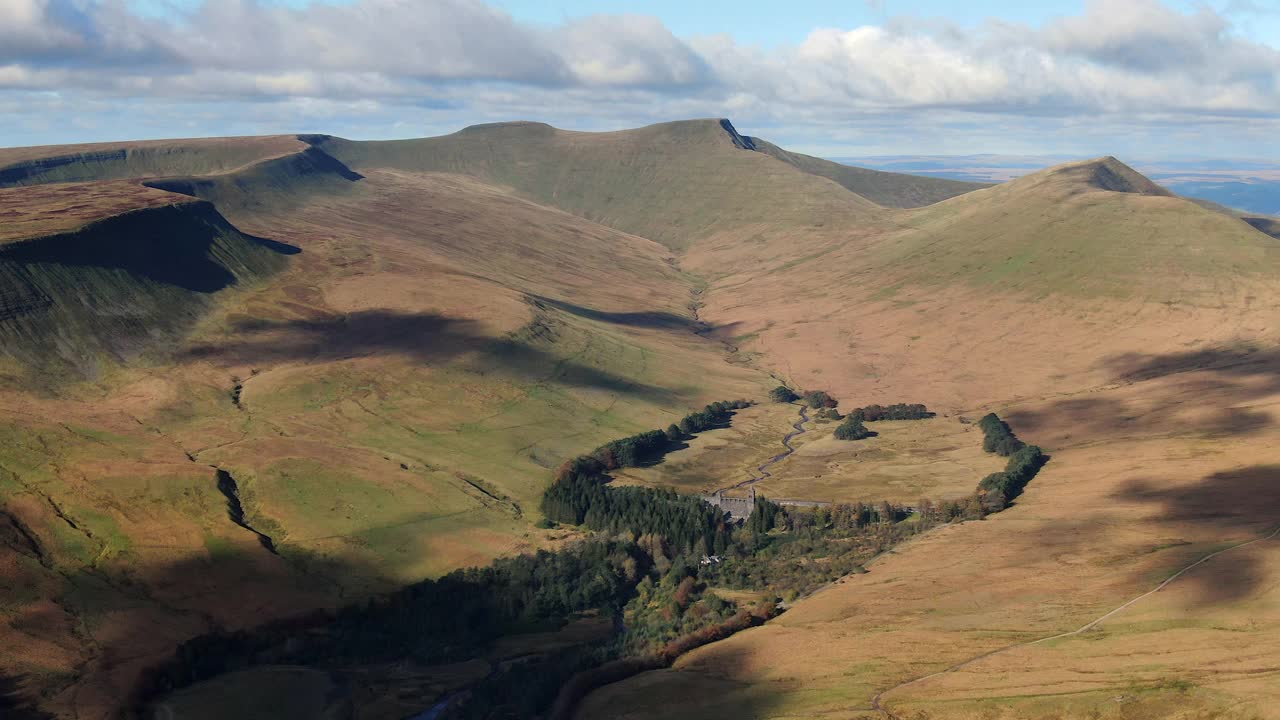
[0,0,1280,159]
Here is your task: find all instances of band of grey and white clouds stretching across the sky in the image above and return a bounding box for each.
[0,0,1280,154]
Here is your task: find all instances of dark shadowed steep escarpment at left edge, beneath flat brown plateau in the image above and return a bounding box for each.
[0,202,294,377]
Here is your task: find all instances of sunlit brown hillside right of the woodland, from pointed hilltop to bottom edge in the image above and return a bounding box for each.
[579,159,1280,720]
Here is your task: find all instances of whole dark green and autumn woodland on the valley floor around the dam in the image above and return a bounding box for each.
[137,396,1047,719]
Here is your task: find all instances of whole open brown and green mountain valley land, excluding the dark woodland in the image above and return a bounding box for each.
[0,114,1280,720]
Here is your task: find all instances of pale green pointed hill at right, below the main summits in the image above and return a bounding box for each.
[876,158,1280,299]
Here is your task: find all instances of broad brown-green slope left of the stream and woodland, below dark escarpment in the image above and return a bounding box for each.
[0,151,768,719]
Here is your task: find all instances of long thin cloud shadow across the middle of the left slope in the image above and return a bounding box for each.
[184,310,675,404]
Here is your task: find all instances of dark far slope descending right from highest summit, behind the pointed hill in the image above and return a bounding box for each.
[748,137,989,208]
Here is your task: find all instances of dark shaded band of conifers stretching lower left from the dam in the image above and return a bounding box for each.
[137,539,652,705]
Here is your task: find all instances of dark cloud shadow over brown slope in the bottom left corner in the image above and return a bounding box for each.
[17,530,398,720]
